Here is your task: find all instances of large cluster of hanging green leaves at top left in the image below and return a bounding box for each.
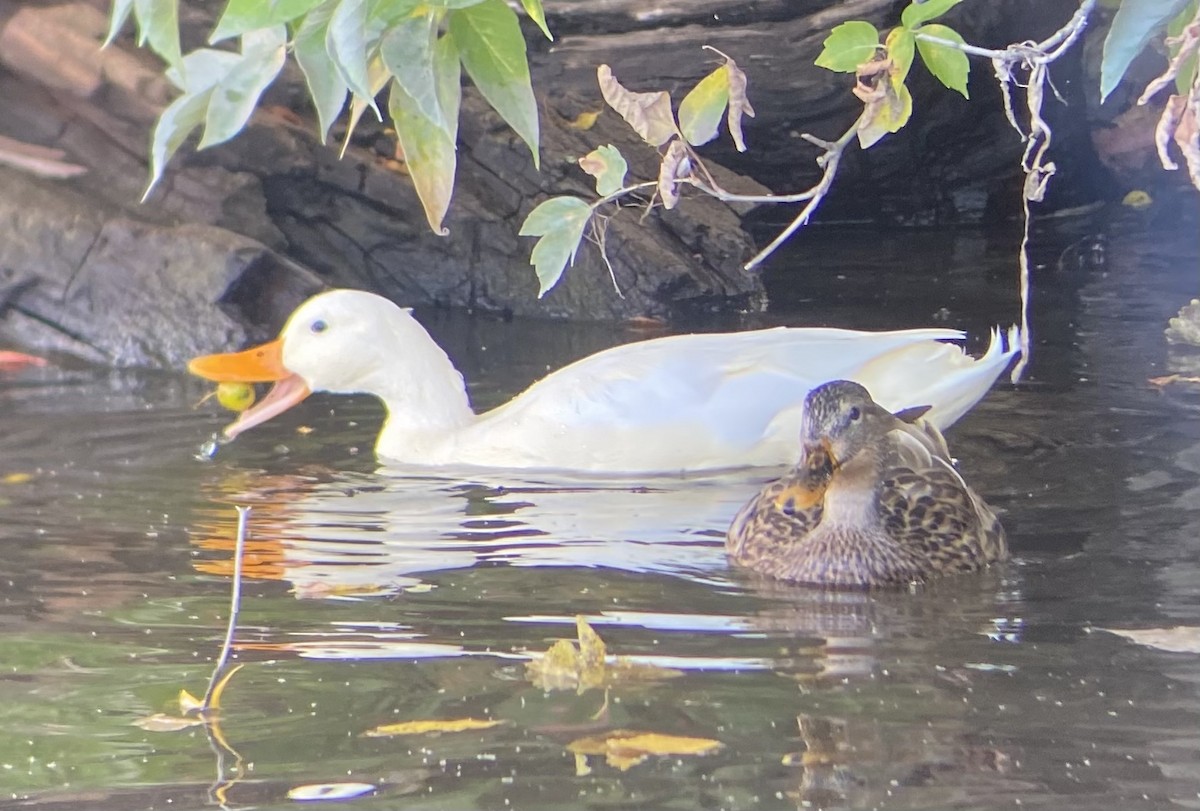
[108,0,550,233]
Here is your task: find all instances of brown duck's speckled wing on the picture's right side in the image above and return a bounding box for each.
[880,455,1008,573]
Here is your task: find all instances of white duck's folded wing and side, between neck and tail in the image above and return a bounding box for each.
[455,329,998,473]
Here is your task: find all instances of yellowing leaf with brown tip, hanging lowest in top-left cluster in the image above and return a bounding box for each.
[388,80,457,236]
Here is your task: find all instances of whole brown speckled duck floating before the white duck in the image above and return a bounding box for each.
[726,380,1008,588]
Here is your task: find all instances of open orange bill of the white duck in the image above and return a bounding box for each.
[187,340,312,439]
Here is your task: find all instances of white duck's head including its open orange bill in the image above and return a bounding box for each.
[187,290,462,438]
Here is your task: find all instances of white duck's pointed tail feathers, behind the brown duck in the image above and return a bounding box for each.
[854,326,1021,431]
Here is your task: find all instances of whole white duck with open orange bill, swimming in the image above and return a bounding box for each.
[188,290,1016,474]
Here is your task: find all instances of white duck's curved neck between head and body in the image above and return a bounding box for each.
[361,317,475,459]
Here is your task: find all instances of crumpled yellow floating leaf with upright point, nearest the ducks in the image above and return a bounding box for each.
[526,617,682,692]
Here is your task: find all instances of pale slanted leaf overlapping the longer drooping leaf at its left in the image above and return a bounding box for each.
[199,25,288,149]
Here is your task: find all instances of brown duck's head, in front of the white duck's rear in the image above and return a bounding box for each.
[800,380,929,467]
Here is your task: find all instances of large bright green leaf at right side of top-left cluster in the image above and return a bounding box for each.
[449,0,539,166]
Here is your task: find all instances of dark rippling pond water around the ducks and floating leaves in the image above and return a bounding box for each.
[0,220,1200,810]
